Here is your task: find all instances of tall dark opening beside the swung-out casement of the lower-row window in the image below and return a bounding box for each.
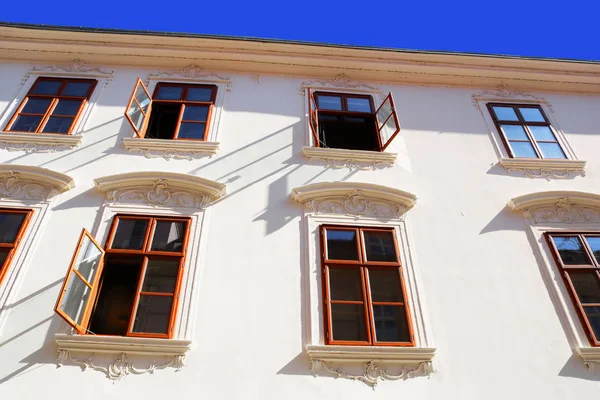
[89,256,144,336]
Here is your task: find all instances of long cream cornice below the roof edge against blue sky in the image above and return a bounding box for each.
[0,26,600,94]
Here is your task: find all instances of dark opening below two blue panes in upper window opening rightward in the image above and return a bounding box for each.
[319,112,379,151]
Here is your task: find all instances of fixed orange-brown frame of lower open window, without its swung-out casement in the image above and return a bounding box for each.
[100,214,191,338]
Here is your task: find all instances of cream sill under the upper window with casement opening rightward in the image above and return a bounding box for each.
[302,147,398,170]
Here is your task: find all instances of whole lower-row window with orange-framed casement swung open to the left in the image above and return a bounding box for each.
[55,215,190,338]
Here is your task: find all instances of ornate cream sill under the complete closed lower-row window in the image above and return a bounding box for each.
[306,345,436,387]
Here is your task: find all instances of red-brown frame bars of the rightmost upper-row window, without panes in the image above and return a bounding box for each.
[487,103,569,160]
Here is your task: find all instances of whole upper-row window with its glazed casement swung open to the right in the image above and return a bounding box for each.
[308,89,400,151]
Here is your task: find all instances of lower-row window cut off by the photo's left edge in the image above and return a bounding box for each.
[0,209,33,283]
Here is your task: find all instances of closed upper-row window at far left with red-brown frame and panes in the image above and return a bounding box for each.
[5,78,97,134]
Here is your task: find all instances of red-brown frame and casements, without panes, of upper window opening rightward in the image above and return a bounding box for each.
[308,88,400,151]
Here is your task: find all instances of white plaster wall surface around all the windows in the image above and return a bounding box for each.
[0,63,600,400]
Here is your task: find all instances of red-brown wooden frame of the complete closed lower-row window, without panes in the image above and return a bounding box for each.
[320,225,415,347]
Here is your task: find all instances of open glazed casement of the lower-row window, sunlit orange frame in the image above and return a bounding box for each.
[54,229,105,333]
